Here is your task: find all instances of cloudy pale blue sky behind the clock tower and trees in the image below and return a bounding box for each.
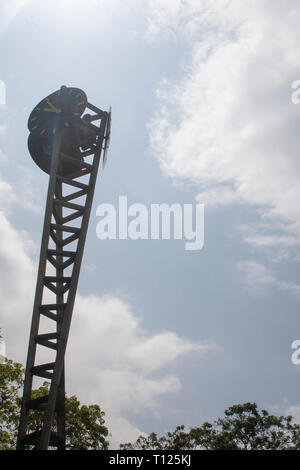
[0,0,300,447]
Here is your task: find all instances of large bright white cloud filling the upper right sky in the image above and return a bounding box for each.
[149,0,300,253]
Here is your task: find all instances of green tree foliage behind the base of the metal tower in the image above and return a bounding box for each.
[0,334,109,450]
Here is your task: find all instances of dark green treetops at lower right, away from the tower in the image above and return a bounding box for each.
[120,403,300,450]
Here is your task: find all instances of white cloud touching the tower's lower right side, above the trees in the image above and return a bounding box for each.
[67,295,217,446]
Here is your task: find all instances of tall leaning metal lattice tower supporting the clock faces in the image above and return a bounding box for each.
[17,87,111,450]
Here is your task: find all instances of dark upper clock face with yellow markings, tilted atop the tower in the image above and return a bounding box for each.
[28,87,87,136]
